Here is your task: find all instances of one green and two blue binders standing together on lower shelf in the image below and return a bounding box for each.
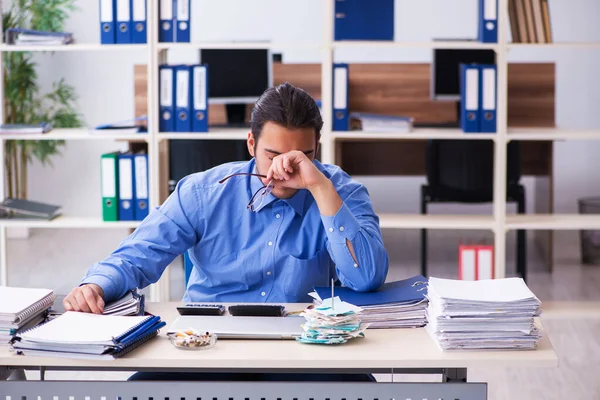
[101,152,149,221]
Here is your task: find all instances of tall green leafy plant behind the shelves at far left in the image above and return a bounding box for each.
[2,0,83,236]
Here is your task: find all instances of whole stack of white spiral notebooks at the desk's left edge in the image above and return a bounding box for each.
[0,286,56,344]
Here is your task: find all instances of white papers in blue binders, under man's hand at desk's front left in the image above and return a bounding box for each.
[11,311,165,359]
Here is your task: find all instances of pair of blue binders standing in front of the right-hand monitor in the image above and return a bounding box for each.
[459,64,498,133]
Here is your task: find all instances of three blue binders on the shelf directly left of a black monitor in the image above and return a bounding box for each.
[159,64,208,132]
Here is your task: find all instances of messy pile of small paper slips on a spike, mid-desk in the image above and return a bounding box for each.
[296,297,368,344]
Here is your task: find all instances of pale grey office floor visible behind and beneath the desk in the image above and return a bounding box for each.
[8,229,600,400]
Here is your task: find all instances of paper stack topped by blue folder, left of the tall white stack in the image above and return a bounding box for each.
[311,275,427,329]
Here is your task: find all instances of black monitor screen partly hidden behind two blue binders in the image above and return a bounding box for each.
[431,49,496,99]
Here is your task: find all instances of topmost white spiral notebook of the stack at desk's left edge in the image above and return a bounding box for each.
[0,286,56,326]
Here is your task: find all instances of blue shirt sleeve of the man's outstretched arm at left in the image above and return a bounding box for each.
[81,176,201,301]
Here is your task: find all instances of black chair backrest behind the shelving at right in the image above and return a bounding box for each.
[426,139,521,194]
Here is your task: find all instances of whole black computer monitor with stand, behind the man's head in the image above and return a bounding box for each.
[199,49,273,125]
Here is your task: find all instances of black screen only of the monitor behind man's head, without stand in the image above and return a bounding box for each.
[200,49,271,99]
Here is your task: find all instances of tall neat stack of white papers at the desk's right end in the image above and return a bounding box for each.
[426,278,541,350]
